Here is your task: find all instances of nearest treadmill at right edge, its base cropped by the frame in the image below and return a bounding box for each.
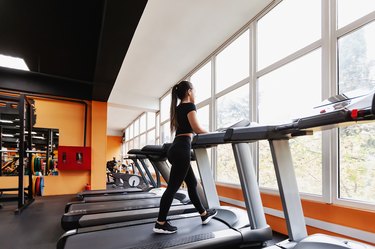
[225,92,375,249]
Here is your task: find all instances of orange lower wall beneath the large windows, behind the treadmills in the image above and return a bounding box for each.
[216,184,375,244]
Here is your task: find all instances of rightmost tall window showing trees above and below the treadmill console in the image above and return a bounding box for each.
[338,20,375,203]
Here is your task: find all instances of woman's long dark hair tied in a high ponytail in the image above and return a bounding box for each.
[170,80,193,133]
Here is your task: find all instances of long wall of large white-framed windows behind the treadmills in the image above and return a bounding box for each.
[149,0,375,212]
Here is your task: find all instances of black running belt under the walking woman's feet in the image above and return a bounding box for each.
[58,216,242,249]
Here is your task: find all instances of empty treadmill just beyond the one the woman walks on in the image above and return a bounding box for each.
[61,145,195,231]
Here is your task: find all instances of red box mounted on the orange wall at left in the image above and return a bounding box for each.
[58,146,91,170]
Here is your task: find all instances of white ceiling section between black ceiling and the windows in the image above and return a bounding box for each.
[107,0,272,135]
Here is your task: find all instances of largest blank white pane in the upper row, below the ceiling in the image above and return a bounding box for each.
[257,0,321,69]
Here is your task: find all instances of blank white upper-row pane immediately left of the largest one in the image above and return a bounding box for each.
[216,31,250,92]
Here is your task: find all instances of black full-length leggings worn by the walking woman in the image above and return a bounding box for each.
[158,136,205,222]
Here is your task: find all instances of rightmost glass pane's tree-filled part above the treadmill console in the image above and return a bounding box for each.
[338,20,375,93]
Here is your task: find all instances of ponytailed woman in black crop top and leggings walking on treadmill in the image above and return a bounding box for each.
[153,81,217,234]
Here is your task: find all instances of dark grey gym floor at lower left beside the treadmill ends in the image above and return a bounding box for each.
[0,195,286,249]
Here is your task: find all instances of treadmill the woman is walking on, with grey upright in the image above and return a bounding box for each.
[57,119,272,249]
